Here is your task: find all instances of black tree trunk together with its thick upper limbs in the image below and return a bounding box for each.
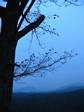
[0,0,79,112]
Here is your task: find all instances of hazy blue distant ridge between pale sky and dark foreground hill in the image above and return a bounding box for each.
[13,83,84,93]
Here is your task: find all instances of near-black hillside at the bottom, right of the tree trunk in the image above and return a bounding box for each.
[11,89,84,112]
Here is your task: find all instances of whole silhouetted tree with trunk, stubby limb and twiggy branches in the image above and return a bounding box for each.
[0,0,77,112]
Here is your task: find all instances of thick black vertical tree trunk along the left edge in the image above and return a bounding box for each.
[0,0,19,112]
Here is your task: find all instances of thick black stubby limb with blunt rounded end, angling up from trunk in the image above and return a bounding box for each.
[16,15,45,39]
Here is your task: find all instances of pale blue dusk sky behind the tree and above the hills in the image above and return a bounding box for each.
[0,0,84,92]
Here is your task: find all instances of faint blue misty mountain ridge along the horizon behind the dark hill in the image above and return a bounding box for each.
[14,83,84,93]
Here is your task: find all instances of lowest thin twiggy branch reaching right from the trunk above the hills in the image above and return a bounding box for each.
[14,49,77,79]
